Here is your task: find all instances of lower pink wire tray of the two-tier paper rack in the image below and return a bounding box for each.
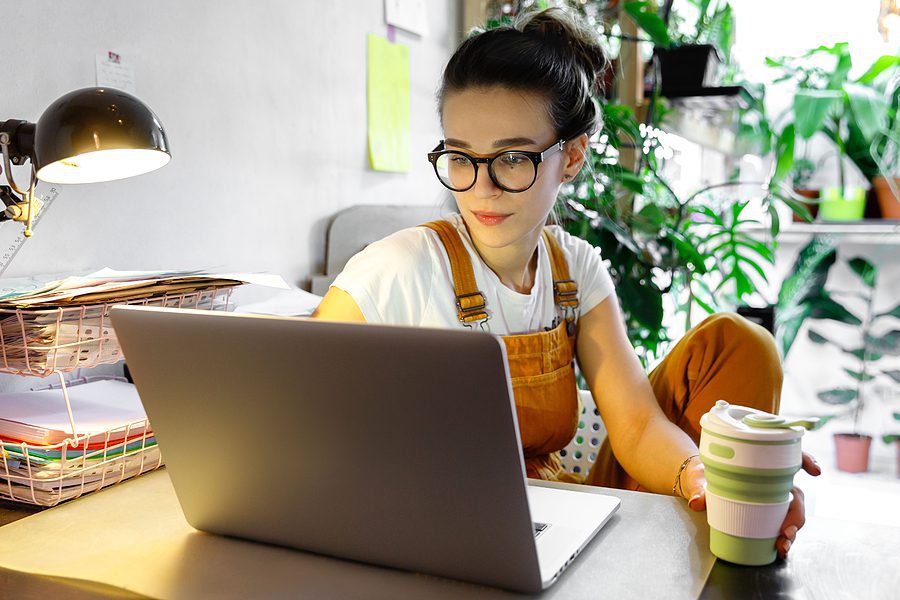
[0,378,163,506]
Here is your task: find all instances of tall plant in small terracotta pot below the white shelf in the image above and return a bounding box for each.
[778,237,900,472]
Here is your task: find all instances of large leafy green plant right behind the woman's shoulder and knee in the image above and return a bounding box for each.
[561,103,778,365]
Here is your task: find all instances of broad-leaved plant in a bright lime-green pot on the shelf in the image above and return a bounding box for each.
[766,43,900,221]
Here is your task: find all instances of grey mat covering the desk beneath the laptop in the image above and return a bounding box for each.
[0,470,714,599]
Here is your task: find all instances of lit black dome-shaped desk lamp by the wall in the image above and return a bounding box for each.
[0,87,171,237]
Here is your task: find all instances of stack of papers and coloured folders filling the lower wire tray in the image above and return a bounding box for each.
[0,380,161,505]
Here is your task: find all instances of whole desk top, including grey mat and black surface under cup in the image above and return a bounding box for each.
[0,470,900,600]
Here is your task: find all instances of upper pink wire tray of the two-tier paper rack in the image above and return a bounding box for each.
[0,286,233,377]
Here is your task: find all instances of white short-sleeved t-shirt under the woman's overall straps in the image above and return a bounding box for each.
[332,214,614,335]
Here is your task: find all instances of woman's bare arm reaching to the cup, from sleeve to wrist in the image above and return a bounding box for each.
[577,294,699,494]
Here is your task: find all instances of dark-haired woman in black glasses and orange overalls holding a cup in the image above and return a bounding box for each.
[314,9,819,556]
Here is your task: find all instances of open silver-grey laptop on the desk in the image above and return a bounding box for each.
[110,306,619,592]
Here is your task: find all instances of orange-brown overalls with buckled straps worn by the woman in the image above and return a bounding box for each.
[424,221,783,489]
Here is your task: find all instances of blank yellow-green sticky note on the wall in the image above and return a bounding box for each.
[367,34,411,171]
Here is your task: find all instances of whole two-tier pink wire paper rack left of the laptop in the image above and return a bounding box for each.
[0,286,234,506]
